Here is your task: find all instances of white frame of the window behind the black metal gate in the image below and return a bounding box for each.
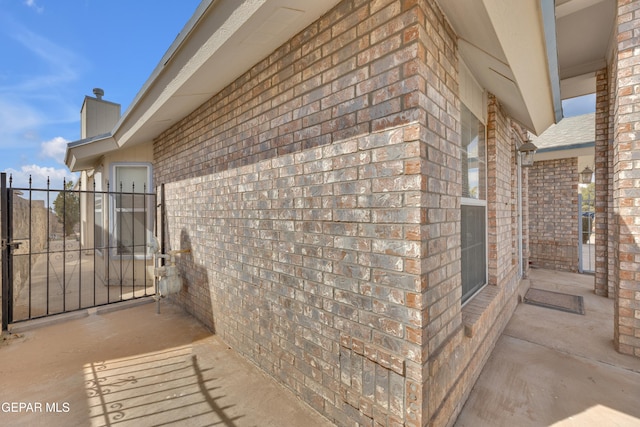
[110,162,153,260]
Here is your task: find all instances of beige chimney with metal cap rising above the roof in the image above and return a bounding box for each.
[80,87,120,139]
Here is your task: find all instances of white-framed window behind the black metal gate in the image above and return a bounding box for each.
[110,163,153,258]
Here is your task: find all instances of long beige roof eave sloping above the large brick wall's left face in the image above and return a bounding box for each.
[66,0,339,170]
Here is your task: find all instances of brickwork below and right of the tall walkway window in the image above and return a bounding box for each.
[425,96,528,426]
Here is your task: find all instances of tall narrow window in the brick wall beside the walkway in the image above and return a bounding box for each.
[461,104,487,303]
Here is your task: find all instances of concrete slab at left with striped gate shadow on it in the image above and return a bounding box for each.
[0,303,333,427]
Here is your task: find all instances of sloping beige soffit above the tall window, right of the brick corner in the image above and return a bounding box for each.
[439,0,560,133]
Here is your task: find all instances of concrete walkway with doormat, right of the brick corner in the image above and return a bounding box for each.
[456,270,640,427]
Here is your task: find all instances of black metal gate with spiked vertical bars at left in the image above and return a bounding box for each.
[0,173,156,329]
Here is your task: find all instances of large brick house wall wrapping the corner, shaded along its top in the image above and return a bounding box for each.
[154,0,528,426]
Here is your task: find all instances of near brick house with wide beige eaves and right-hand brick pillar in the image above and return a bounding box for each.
[66,0,640,426]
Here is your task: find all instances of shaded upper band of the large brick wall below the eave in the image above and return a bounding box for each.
[154,0,430,180]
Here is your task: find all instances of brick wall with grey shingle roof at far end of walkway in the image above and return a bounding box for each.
[529,113,596,272]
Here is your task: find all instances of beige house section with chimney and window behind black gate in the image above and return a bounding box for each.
[69,88,155,288]
